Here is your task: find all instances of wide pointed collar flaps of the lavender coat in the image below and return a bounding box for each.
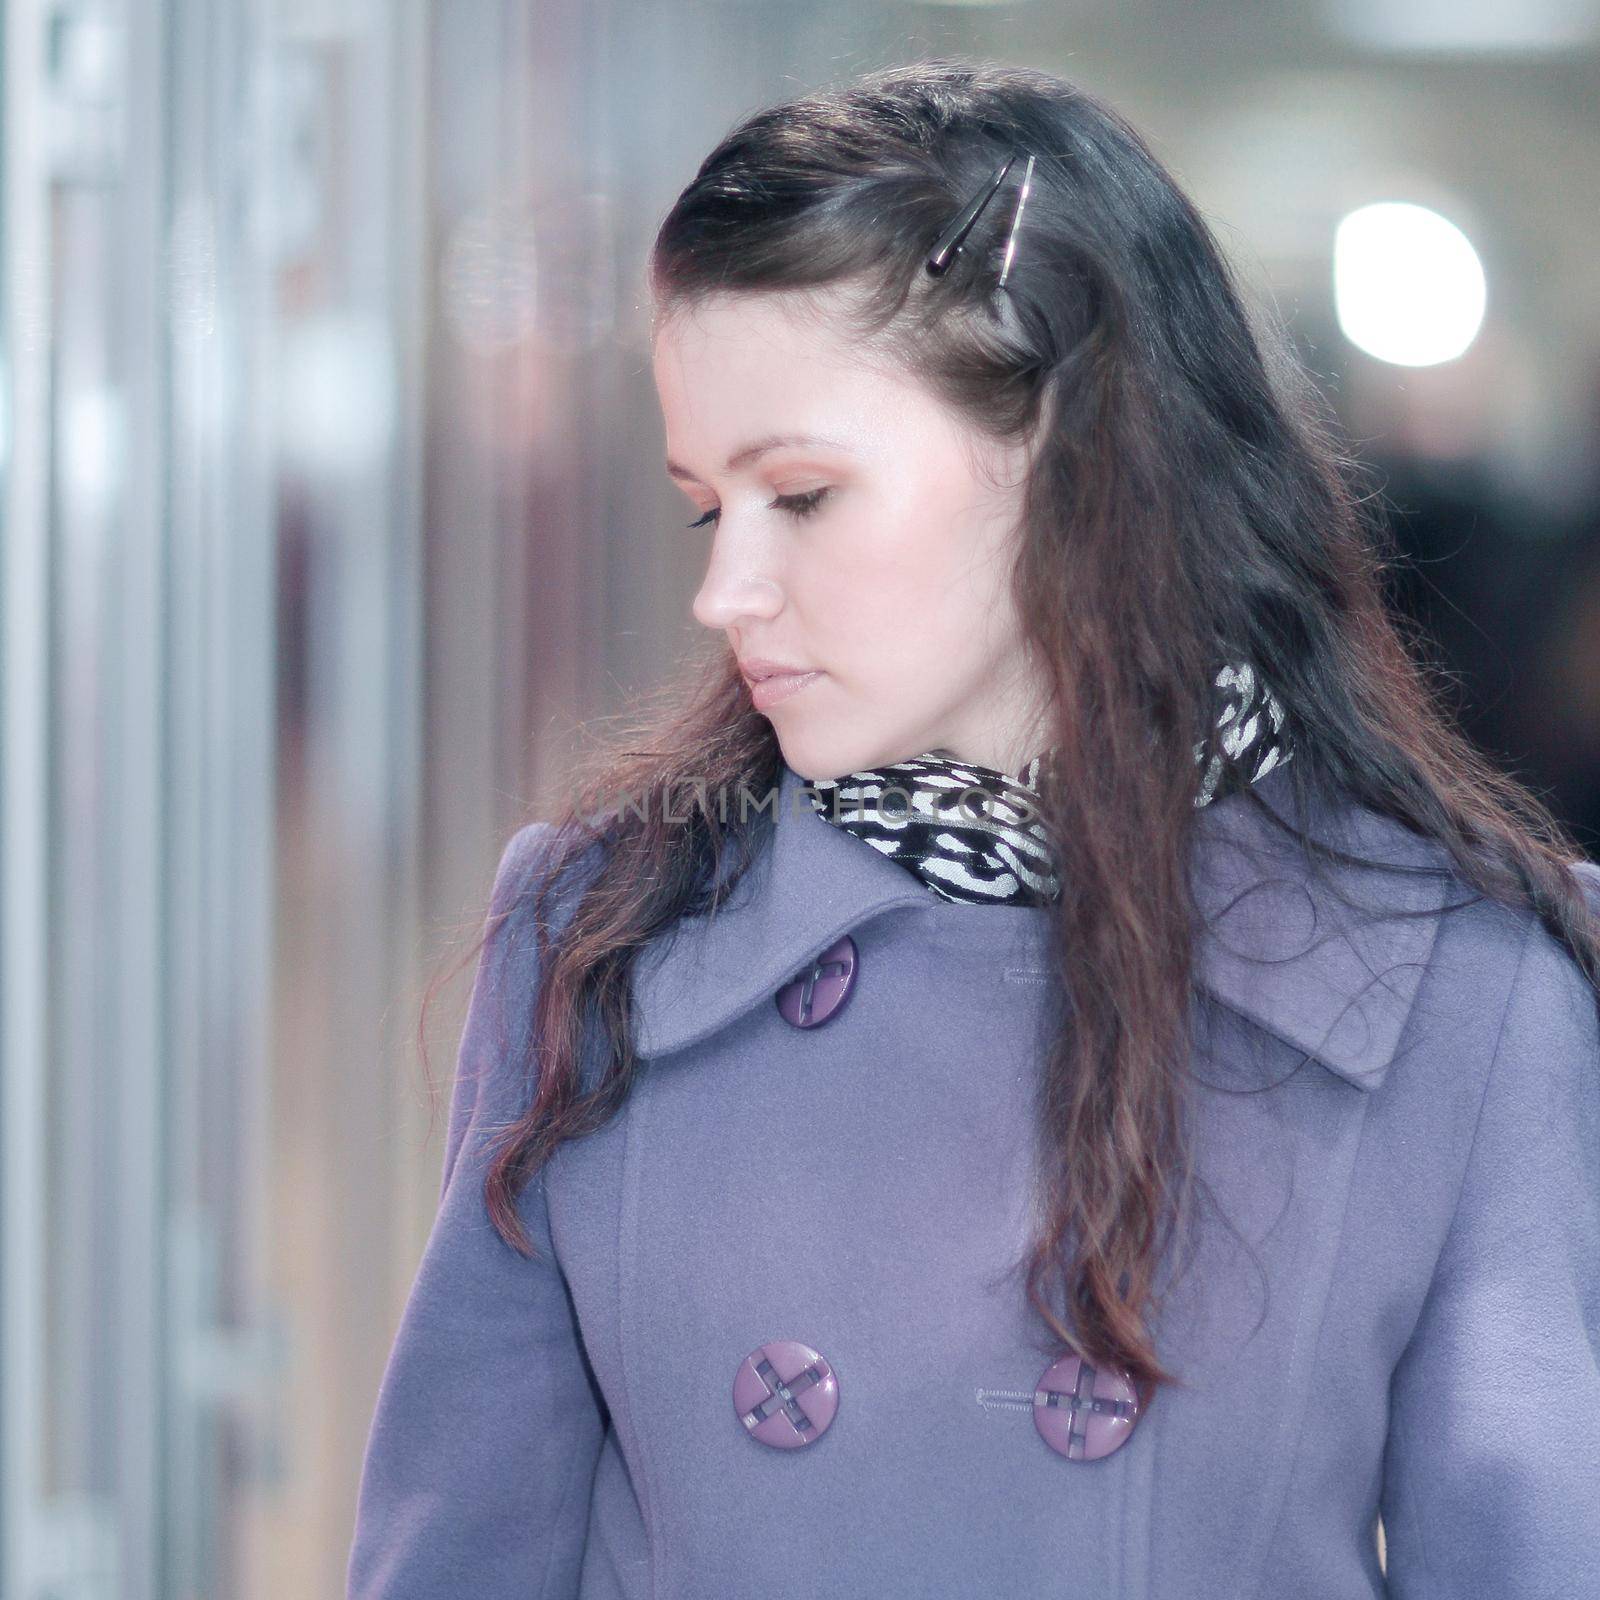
[632,763,1448,1090]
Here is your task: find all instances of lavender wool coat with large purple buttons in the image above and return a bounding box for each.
[347,768,1600,1600]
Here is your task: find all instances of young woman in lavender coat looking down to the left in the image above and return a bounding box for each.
[349,61,1600,1600]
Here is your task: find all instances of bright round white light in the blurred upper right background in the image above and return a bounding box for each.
[1333,200,1488,366]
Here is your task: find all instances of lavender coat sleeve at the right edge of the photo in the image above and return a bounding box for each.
[1382,862,1600,1600]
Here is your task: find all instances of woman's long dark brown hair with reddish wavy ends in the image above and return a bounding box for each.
[419,59,1600,1394]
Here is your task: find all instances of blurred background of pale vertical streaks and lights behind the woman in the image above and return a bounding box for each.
[0,0,1600,1600]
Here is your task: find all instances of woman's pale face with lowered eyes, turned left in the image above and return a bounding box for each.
[653,294,1042,778]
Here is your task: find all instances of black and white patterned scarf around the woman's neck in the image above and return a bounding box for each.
[806,662,1291,906]
